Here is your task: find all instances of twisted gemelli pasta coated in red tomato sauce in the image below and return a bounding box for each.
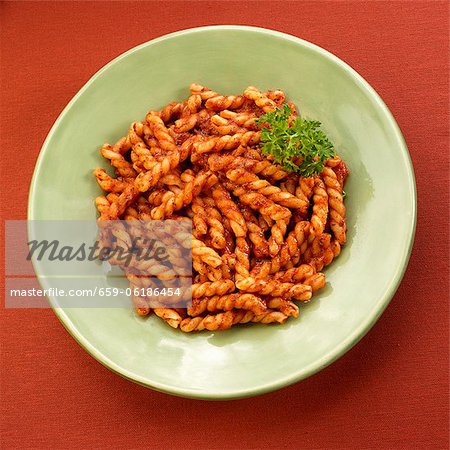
[94,83,348,332]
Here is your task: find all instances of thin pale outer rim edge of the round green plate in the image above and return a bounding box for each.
[27,25,417,400]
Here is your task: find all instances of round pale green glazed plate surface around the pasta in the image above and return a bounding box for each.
[28,26,416,399]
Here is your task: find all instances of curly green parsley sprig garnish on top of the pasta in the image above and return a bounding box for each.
[256,105,334,177]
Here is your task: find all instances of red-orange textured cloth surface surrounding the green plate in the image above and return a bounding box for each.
[0,1,449,449]
